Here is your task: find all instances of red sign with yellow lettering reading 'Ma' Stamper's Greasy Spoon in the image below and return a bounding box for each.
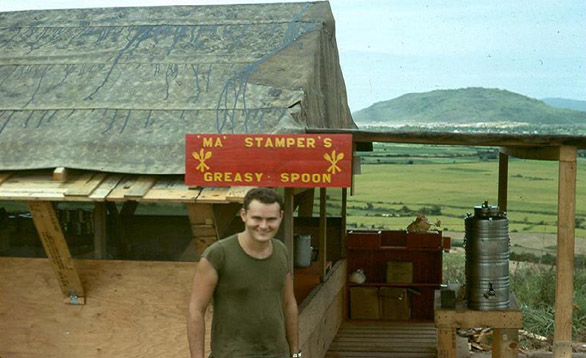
[185,134,352,188]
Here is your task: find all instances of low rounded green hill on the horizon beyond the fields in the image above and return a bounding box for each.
[352,88,586,127]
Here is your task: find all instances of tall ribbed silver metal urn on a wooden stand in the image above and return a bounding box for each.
[464,201,510,311]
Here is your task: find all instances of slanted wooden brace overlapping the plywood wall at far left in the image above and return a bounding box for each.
[28,201,85,304]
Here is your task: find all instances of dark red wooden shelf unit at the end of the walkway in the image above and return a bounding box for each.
[347,230,442,321]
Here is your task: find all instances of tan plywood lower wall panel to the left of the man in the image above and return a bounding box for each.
[0,258,211,358]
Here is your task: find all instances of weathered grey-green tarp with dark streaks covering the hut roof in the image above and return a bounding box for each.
[0,2,356,174]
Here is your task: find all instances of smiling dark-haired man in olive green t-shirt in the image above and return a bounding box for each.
[187,188,301,358]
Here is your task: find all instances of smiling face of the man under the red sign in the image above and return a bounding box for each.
[240,200,283,242]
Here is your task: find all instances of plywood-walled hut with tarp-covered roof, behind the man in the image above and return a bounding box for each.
[0,2,356,357]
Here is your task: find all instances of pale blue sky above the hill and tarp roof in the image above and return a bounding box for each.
[0,0,586,111]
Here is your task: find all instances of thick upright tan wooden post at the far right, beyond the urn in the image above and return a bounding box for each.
[553,147,576,358]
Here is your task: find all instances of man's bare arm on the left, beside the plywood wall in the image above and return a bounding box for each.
[187,258,218,358]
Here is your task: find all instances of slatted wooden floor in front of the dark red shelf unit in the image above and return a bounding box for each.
[326,321,437,358]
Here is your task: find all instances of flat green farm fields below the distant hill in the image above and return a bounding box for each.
[329,144,586,238]
